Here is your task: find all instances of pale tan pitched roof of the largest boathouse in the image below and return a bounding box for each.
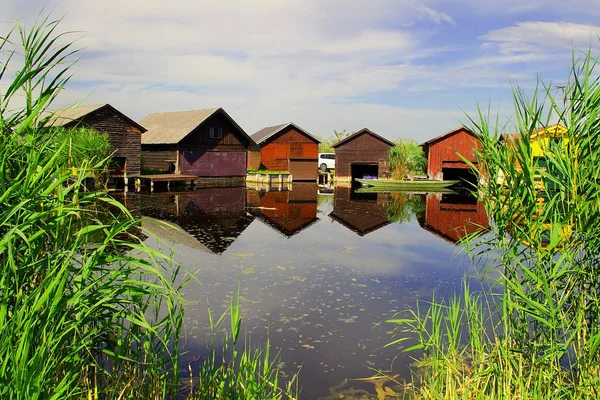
[140,108,253,144]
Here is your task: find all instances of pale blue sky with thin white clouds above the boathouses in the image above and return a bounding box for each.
[0,0,600,142]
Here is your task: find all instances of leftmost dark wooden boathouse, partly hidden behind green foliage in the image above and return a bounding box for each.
[50,104,146,181]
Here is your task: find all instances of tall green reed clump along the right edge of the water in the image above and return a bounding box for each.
[389,48,600,399]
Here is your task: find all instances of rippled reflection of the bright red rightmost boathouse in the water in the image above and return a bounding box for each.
[419,193,489,243]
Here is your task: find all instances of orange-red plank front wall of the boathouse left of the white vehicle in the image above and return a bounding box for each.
[261,126,319,173]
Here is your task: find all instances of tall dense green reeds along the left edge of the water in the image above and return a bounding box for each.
[0,14,183,399]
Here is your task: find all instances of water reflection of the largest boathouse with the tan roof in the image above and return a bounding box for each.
[142,187,254,254]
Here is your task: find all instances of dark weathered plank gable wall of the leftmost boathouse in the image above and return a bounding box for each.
[65,106,142,176]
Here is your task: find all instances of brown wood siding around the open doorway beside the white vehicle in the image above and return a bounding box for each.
[335,132,391,180]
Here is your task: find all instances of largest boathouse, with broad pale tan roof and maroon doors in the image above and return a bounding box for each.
[140,108,253,178]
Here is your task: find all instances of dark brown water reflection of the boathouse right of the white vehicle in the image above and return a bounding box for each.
[329,186,390,236]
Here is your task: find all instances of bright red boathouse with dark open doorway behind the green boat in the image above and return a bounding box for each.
[421,126,481,183]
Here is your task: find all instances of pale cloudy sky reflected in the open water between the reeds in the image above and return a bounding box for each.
[136,188,492,399]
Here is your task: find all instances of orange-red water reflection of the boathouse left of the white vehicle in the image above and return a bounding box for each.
[247,183,319,237]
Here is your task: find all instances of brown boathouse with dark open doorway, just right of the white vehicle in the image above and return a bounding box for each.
[331,128,394,182]
